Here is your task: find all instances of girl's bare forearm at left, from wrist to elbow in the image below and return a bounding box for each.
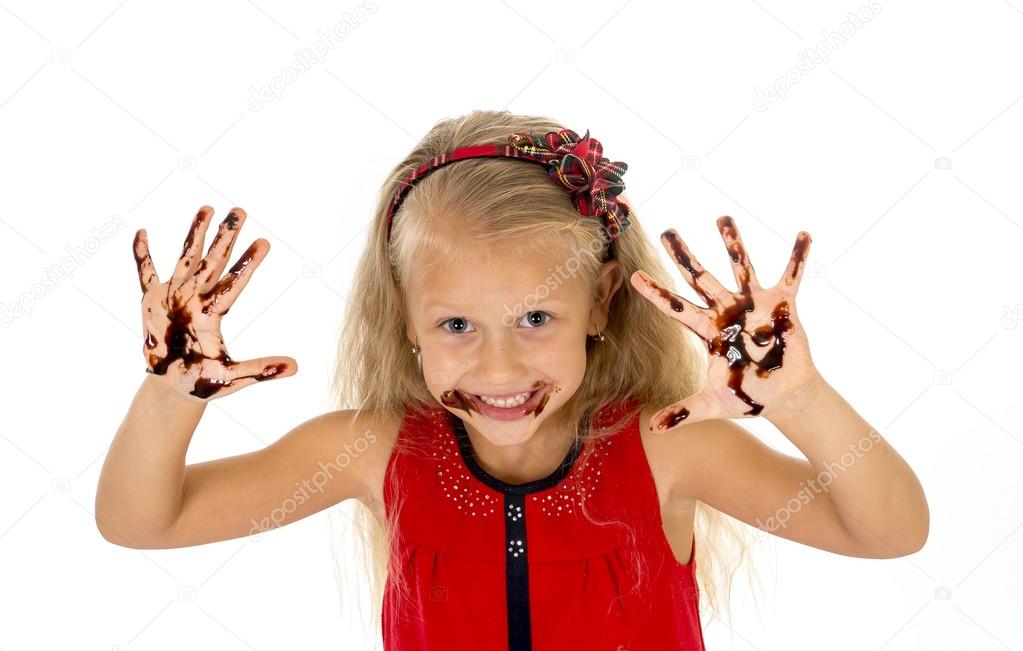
[95,375,207,546]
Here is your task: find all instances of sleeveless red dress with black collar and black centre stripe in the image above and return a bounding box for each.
[383,402,704,651]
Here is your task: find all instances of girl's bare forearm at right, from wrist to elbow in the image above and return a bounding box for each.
[764,376,930,556]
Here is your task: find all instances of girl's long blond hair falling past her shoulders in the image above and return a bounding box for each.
[331,111,761,642]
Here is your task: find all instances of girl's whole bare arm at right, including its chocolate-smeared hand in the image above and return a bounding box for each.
[632,216,929,558]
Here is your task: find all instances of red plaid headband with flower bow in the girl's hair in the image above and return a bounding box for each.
[387,129,630,246]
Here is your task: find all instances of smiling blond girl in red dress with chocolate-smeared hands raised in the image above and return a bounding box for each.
[96,111,928,651]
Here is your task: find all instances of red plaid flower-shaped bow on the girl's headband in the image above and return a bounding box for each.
[508,129,630,240]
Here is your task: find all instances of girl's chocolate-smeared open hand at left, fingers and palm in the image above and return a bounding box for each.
[134,206,298,400]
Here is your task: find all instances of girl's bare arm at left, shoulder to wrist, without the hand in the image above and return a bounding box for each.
[96,370,385,549]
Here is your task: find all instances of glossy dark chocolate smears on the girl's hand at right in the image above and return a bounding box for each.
[654,217,809,429]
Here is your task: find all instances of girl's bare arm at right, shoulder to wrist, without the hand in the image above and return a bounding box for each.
[653,378,929,558]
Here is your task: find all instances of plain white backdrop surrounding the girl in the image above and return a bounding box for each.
[0,0,1023,651]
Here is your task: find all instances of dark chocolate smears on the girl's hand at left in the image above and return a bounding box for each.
[135,211,287,399]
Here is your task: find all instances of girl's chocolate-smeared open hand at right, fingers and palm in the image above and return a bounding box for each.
[631,216,820,431]
